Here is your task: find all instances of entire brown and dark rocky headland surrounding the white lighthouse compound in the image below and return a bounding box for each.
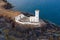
[0,0,60,40]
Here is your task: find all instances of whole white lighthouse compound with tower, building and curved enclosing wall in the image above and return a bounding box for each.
[15,10,39,25]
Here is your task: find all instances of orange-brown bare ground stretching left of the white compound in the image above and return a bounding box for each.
[0,1,21,18]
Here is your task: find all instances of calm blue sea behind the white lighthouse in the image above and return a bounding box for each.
[8,0,60,25]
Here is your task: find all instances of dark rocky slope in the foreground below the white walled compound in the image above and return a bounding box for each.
[0,16,60,40]
